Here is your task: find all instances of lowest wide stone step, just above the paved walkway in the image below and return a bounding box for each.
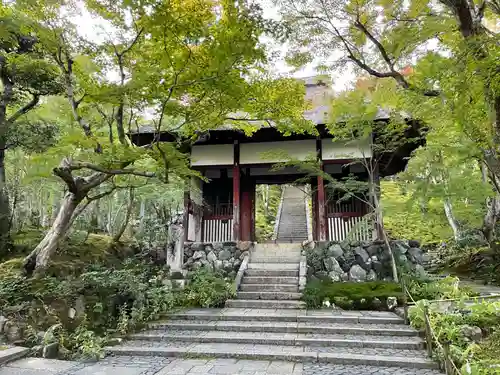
[105,340,437,369]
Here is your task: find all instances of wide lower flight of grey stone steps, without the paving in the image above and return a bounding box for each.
[106,308,440,375]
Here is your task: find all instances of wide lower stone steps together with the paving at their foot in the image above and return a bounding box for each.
[0,308,446,375]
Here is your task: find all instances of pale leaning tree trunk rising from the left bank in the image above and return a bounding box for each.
[24,192,82,275]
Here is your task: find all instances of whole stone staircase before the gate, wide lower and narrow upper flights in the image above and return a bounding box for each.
[106,243,440,375]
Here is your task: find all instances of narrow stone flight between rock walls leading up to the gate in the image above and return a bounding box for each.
[226,243,304,309]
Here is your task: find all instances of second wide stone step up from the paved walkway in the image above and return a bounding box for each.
[129,331,424,350]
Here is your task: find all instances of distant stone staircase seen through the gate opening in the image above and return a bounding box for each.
[276,186,307,242]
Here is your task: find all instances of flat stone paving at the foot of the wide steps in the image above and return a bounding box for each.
[0,357,441,375]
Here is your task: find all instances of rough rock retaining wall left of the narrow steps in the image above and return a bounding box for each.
[182,241,253,274]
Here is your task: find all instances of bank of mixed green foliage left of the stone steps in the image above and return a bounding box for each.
[0,234,234,358]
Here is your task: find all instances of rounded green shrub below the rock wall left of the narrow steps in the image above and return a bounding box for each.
[184,268,235,307]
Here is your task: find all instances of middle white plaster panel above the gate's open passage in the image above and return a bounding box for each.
[240,139,316,165]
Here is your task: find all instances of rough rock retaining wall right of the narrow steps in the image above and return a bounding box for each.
[303,240,427,282]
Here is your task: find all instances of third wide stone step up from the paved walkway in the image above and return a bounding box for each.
[150,319,419,337]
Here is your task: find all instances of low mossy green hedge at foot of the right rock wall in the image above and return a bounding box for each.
[302,280,402,310]
